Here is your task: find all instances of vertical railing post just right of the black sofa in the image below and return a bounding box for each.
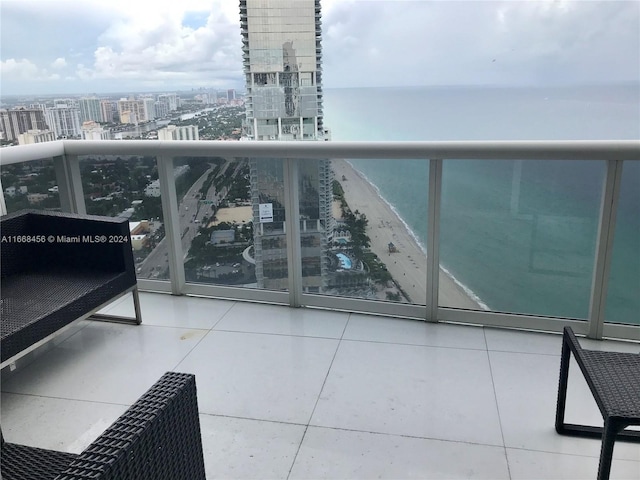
[157,156,185,295]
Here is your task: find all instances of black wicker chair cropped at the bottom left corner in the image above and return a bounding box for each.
[0,372,206,480]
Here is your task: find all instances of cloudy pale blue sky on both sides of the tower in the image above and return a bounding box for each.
[0,0,640,95]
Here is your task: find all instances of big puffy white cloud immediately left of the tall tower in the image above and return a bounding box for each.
[73,0,242,84]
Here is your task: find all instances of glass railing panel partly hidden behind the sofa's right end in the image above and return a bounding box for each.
[79,155,169,280]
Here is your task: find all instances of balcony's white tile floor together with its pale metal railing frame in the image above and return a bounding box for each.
[0,141,640,478]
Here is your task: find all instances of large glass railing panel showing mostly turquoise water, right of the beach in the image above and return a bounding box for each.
[439,160,605,319]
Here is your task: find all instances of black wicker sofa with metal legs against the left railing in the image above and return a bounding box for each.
[0,210,141,368]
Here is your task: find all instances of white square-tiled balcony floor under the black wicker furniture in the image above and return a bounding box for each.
[1,294,640,480]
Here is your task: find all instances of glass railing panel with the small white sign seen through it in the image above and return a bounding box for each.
[182,157,288,291]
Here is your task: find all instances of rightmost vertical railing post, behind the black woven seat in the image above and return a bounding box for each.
[588,160,622,339]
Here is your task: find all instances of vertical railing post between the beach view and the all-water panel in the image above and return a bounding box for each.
[427,158,442,322]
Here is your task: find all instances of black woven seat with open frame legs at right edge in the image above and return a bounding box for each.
[556,327,640,480]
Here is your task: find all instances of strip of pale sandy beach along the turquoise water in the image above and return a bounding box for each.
[332,159,482,310]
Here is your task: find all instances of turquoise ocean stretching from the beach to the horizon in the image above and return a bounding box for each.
[324,86,640,324]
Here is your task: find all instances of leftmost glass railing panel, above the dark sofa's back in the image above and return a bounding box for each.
[0,158,60,213]
